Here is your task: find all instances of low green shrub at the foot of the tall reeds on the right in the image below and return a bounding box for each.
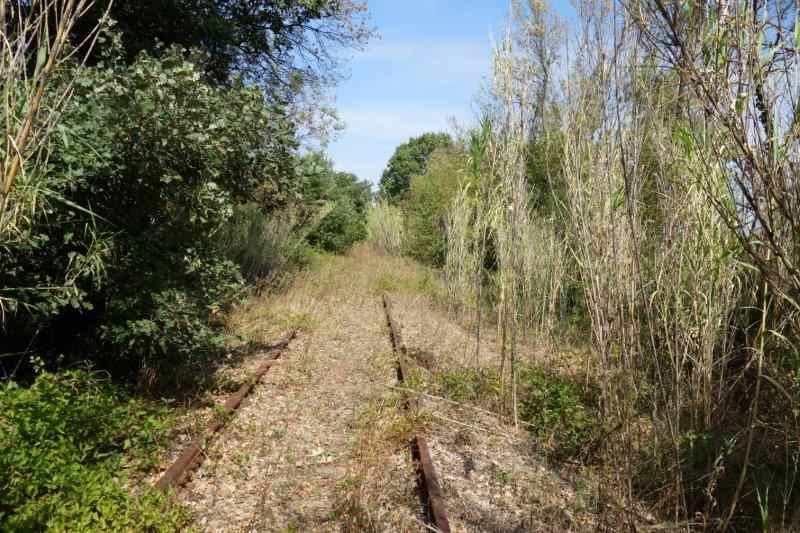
[519,366,597,456]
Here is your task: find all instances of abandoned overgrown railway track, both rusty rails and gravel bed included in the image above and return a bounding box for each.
[142,251,588,533]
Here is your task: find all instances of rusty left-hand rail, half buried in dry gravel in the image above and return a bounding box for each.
[156,331,297,490]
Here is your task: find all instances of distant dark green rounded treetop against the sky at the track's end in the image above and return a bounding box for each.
[380,133,453,201]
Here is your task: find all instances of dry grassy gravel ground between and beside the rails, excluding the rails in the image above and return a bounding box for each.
[173,248,600,533]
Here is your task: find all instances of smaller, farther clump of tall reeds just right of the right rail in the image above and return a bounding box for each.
[445,33,566,423]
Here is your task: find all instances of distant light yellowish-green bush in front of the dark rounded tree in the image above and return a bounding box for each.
[403,149,466,267]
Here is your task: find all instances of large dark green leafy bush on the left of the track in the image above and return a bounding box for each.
[0,46,298,378]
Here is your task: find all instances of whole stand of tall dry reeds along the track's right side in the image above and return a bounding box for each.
[445,0,767,527]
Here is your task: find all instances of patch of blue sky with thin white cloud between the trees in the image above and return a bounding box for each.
[328,0,567,187]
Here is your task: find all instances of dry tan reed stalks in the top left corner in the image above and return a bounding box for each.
[0,0,111,235]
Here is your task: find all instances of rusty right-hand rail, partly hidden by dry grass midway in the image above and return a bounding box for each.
[383,294,451,533]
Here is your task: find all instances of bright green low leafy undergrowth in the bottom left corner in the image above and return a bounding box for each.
[0,371,186,531]
